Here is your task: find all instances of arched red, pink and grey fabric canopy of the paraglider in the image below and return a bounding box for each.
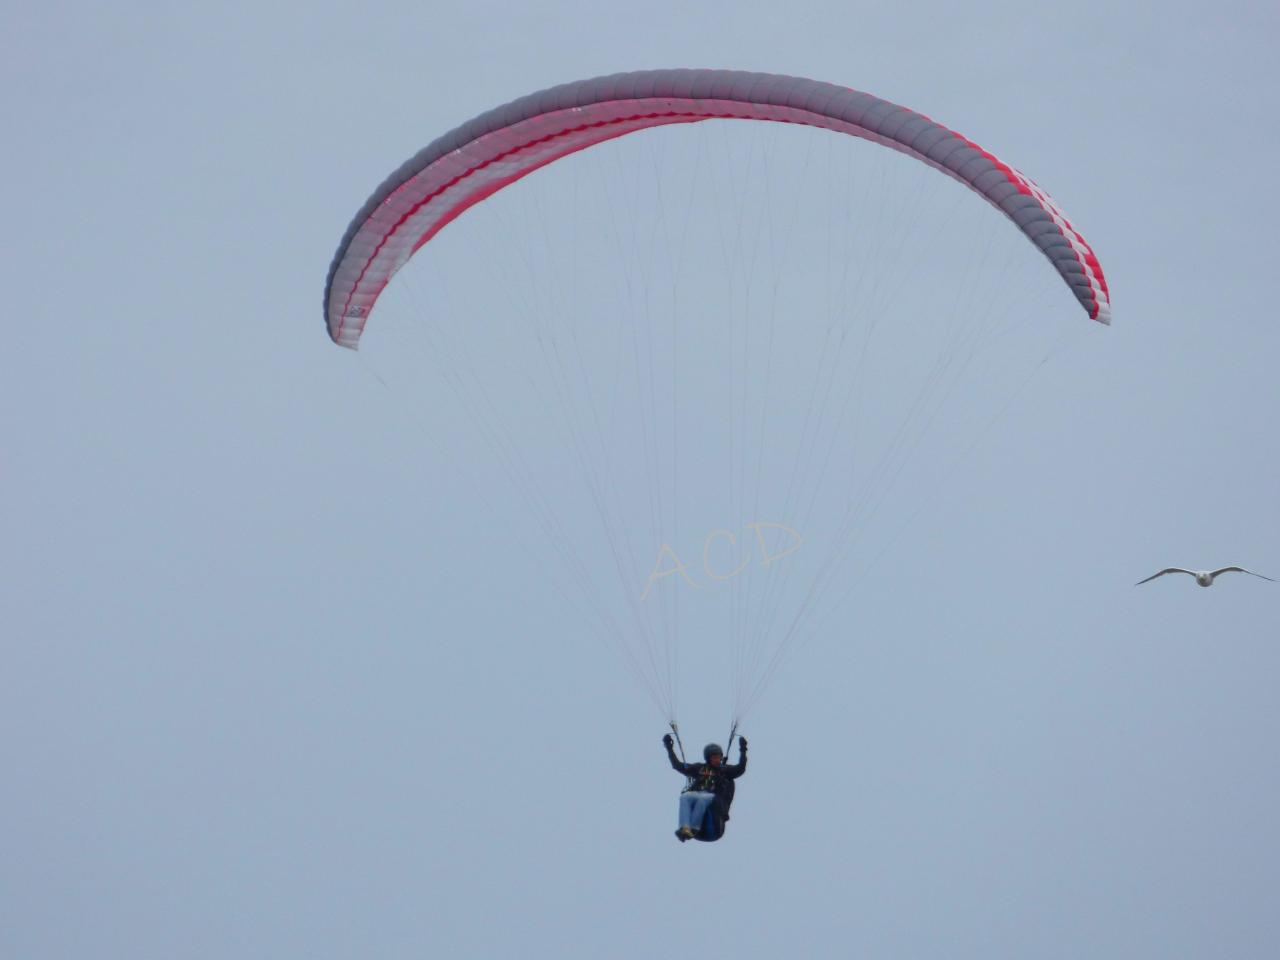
[324,69,1111,348]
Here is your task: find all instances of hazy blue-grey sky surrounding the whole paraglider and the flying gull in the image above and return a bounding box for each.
[0,3,1280,957]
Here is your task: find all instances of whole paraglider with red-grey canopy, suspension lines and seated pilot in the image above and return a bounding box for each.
[324,69,1111,841]
